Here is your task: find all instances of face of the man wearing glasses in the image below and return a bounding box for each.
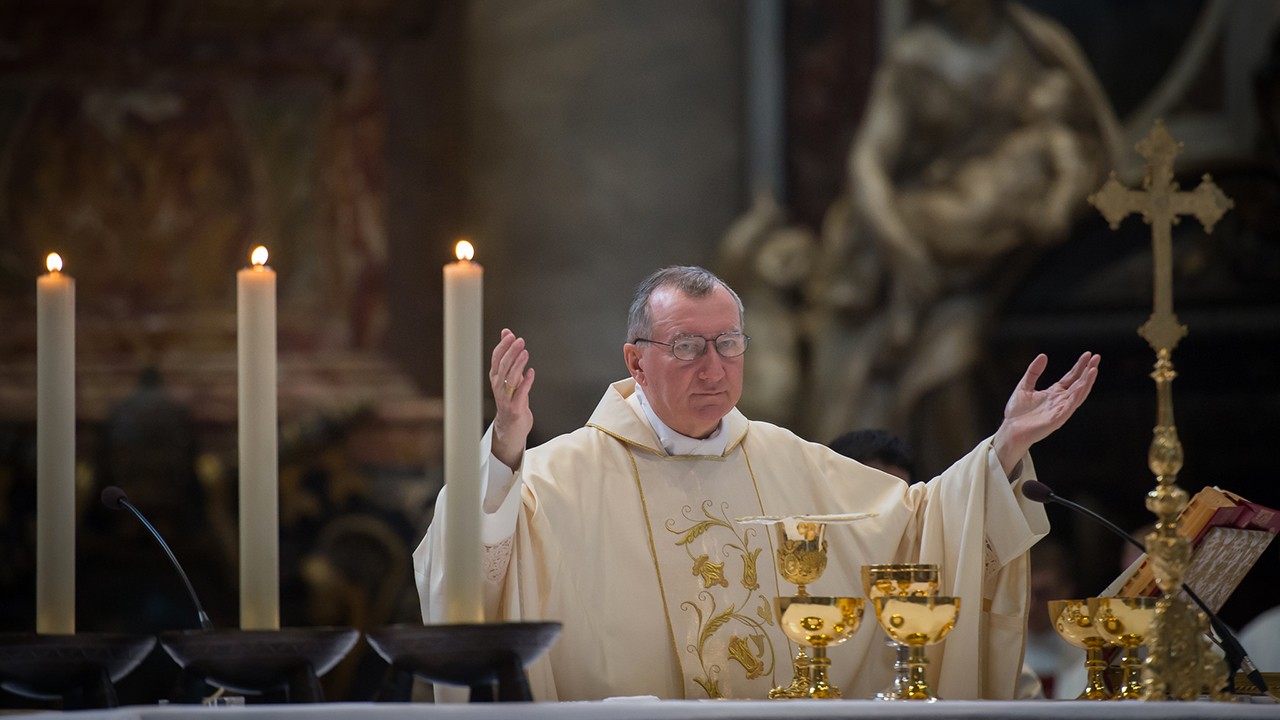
[623,284,744,438]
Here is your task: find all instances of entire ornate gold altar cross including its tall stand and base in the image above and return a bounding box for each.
[1089,120,1234,700]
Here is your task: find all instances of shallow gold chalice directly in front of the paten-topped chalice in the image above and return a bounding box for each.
[771,594,867,698]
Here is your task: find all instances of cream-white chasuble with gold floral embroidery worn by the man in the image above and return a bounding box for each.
[413,379,1048,701]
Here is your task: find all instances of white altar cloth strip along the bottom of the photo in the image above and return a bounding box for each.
[64,700,1280,720]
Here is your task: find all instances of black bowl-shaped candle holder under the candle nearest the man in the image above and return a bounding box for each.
[365,621,562,702]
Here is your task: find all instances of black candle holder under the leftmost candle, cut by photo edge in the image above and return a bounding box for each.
[0,633,156,710]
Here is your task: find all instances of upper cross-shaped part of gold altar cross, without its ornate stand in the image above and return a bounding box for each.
[1089,120,1235,352]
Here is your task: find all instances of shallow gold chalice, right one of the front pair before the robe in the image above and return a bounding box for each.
[872,596,960,702]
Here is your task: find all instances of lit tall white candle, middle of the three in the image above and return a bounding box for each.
[236,247,280,630]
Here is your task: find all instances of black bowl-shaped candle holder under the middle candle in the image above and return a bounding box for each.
[160,628,360,702]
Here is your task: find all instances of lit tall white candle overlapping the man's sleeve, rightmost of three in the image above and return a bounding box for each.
[444,240,484,623]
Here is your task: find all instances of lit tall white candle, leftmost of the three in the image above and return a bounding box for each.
[36,252,76,634]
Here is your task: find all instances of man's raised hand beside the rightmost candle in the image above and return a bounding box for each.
[489,328,534,470]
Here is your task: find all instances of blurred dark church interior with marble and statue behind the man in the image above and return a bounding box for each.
[0,0,1280,708]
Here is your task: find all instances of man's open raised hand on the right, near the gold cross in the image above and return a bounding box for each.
[995,352,1102,474]
